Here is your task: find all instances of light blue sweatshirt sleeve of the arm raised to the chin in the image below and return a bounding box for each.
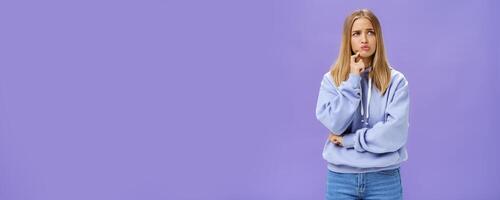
[316,73,361,135]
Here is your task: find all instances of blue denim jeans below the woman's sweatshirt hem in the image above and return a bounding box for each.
[326,168,403,200]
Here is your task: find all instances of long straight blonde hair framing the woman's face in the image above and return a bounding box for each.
[330,9,391,95]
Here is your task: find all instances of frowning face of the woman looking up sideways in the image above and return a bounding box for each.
[351,17,377,58]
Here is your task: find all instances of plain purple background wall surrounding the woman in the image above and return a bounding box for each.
[0,0,500,200]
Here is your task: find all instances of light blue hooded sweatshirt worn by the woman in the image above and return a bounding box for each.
[316,68,410,173]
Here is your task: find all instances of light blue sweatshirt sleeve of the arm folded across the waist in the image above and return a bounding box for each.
[343,77,410,153]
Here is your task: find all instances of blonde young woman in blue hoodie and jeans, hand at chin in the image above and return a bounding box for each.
[316,9,410,199]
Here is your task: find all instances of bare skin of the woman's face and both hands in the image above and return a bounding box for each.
[328,18,377,146]
